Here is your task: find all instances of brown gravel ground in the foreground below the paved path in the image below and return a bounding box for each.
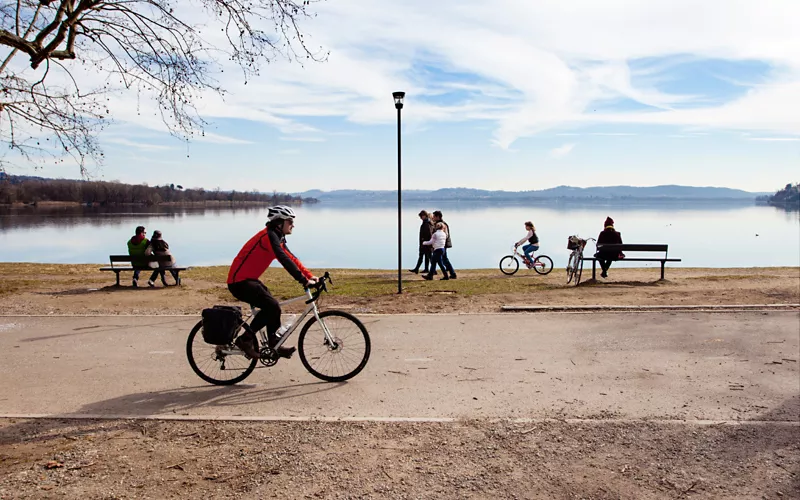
[0,420,800,499]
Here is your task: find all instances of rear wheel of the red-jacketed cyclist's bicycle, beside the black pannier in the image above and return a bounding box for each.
[186,321,257,385]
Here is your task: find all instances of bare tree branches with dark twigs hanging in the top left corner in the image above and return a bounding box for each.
[0,0,327,169]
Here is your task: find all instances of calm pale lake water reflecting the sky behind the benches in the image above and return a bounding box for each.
[0,203,800,269]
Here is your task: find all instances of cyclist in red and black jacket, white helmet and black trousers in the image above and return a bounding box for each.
[228,205,317,358]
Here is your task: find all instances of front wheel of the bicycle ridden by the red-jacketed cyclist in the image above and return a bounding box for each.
[297,311,371,382]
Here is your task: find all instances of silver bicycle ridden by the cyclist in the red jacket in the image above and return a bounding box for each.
[186,272,371,385]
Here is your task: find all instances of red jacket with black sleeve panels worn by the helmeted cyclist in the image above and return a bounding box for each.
[228,228,314,286]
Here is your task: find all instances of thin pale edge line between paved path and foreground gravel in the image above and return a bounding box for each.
[0,413,800,427]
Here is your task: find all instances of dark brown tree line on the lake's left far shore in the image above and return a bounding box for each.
[0,172,317,206]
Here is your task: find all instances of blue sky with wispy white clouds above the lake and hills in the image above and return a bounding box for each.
[3,0,800,192]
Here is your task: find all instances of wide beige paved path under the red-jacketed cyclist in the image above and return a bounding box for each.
[0,311,800,421]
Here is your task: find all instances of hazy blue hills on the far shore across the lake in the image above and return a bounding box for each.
[295,185,766,203]
